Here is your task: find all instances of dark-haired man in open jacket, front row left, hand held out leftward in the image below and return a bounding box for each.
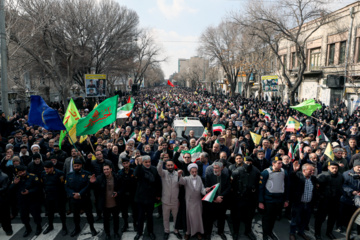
[90,163,120,239]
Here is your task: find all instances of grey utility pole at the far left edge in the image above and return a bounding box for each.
[0,0,9,117]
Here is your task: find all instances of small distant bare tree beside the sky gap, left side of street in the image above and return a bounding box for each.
[130,29,166,85]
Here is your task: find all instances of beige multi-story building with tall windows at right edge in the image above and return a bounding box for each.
[268,1,360,110]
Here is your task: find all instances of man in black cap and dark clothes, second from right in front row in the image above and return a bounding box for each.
[315,161,344,240]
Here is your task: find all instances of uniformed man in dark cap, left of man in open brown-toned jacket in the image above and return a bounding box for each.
[65,158,97,237]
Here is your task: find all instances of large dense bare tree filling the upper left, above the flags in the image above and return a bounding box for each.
[7,0,138,104]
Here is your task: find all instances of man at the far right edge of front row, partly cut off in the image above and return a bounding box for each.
[338,159,360,235]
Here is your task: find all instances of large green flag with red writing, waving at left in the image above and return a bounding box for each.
[76,95,118,136]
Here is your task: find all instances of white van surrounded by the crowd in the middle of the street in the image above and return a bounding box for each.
[172,117,204,138]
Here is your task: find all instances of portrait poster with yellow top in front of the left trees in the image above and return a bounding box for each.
[85,74,106,97]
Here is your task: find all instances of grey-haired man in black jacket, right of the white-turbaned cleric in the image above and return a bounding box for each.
[203,162,231,240]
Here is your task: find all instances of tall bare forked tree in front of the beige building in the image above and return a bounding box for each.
[233,0,329,104]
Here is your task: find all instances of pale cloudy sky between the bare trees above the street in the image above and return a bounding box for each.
[117,0,355,78]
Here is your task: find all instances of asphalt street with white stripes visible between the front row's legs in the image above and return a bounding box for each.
[0,210,354,240]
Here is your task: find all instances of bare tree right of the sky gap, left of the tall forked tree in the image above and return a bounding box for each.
[198,21,242,94]
